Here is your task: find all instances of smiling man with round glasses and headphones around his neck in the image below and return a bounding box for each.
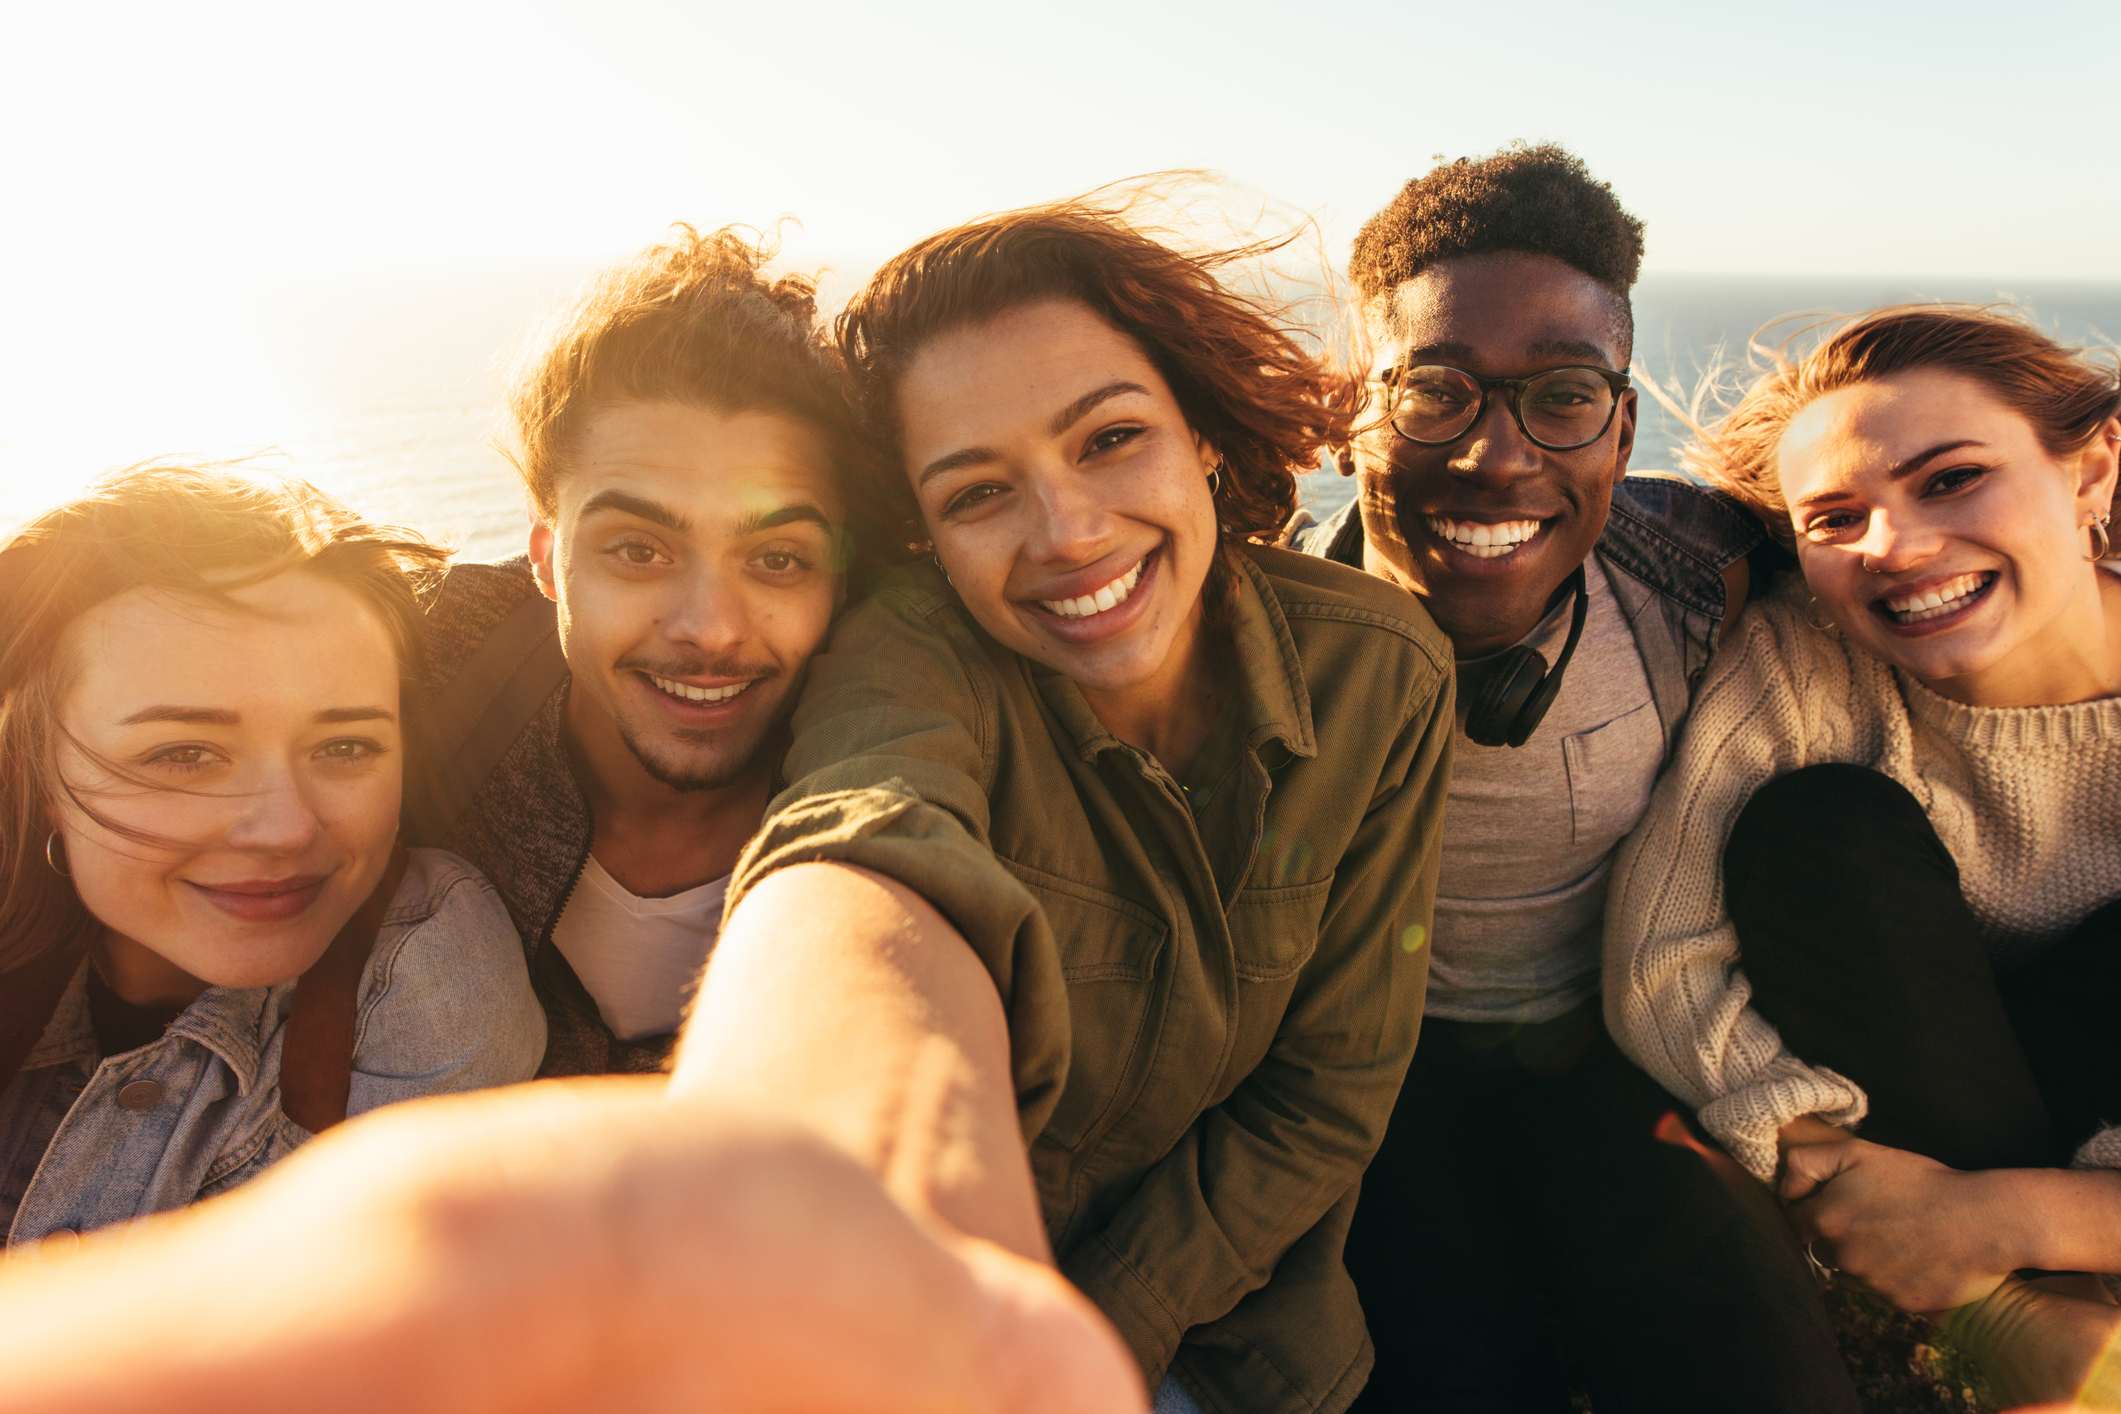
[1292,146,1858,1414]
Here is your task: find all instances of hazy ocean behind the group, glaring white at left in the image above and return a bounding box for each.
[0,263,2121,558]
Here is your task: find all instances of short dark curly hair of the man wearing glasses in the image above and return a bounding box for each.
[1347,142,1642,315]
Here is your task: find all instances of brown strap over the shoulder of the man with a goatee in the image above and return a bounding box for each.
[405,594,566,846]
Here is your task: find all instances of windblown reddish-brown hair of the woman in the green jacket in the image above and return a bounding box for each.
[838,193,1360,568]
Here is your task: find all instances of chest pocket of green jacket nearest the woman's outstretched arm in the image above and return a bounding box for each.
[1010,865,1167,1149]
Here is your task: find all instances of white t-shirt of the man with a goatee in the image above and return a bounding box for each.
[551,854,730,1041]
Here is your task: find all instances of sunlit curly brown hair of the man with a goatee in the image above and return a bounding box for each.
[505,223,865,551]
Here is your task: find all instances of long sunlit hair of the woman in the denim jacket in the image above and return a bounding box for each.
[0,462,448,986]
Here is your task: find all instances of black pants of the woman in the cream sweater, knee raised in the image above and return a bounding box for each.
[1724,765,2121,1168]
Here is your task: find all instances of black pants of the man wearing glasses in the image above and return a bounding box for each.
[1347,1003,1858,1414]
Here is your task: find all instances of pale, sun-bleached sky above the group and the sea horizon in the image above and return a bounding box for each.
[0,0,2121,536]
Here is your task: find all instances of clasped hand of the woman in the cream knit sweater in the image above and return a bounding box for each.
[1782,1136,2019,1312]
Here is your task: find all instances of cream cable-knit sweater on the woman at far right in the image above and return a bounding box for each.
[1606,575,2121,1179]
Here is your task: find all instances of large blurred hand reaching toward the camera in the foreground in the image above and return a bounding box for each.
[0,1081,1147,1414]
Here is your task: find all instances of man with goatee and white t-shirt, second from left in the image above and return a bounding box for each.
[414,227,857,1075]
